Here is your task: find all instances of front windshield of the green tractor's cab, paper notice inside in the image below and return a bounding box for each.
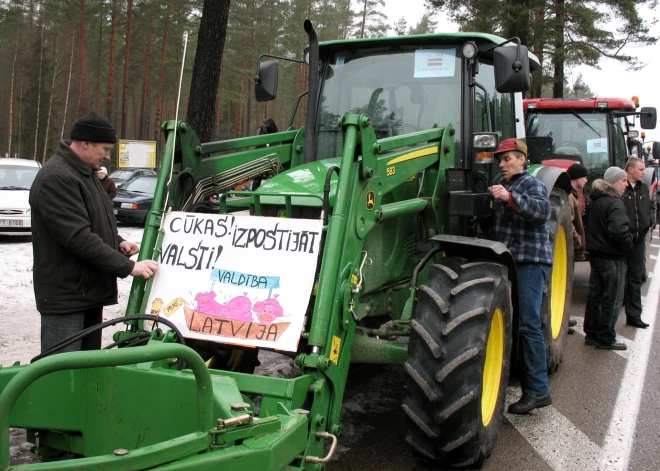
[318,46,461,159]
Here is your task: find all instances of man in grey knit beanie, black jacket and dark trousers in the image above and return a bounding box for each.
[584,167,633,350]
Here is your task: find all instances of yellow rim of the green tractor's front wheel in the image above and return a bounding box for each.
[481,307,504,427]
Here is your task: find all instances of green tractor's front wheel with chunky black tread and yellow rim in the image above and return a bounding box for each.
[402,258,513,467]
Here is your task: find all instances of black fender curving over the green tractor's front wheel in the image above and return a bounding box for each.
[430,236,520,346]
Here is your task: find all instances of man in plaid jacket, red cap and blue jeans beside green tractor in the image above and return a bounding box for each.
[489,138,552,414]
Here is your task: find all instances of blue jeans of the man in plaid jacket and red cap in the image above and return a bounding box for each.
[516,263,550,395]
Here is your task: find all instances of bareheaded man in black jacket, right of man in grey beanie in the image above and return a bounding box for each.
[623,157,653,329]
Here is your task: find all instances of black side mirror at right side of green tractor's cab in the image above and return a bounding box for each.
[493,46,531,93]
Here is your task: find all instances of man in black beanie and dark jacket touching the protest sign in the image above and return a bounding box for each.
[30,111,157,353]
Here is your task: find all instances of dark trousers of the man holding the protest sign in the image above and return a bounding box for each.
[41,307,103,353]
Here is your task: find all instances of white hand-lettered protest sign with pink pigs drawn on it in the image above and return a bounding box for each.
[145,212,323,352]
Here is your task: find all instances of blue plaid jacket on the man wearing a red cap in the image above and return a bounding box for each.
[490,171,553,265]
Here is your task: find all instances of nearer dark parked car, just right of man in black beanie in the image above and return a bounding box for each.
[112,175,158,224]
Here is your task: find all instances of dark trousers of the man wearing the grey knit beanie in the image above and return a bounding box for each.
[584,257,626,345]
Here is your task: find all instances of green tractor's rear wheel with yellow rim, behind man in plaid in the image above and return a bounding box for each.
[541,188,574,374]
